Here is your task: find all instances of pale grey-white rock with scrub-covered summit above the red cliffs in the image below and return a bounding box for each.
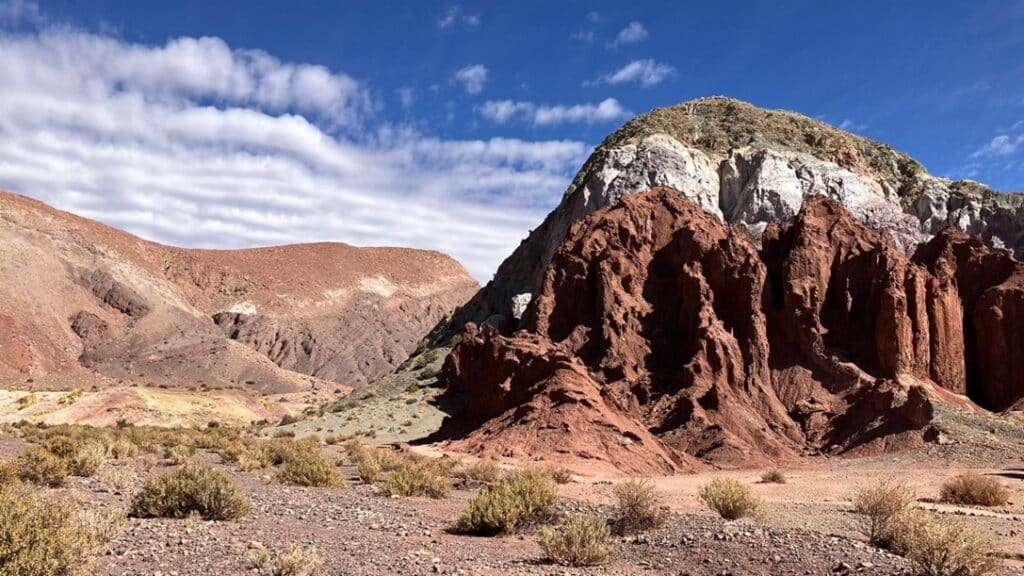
[444,97,1024,341]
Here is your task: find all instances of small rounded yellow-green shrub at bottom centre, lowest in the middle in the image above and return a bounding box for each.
[538,515,618,566]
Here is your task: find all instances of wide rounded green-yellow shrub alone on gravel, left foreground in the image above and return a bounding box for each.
[129,464,251,520]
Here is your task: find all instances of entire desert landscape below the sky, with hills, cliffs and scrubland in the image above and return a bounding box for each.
[0,96,1024,576]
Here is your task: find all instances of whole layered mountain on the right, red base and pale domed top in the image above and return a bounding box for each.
[419,97,1024,474]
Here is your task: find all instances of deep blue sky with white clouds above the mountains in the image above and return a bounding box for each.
[0,0,1024,282]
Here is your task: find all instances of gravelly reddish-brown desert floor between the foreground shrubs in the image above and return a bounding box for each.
[0,437,1024,576]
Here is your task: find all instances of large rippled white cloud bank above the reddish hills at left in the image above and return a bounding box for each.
[0,30,589,281]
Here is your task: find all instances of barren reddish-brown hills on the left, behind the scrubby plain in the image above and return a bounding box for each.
[0,193,477,424]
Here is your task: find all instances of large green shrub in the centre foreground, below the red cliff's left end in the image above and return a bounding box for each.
[456,470,558,535]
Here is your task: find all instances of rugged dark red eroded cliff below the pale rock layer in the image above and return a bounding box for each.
[442,188,1024,472]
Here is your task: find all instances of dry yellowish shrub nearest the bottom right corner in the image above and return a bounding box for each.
[888,508,999,576]
